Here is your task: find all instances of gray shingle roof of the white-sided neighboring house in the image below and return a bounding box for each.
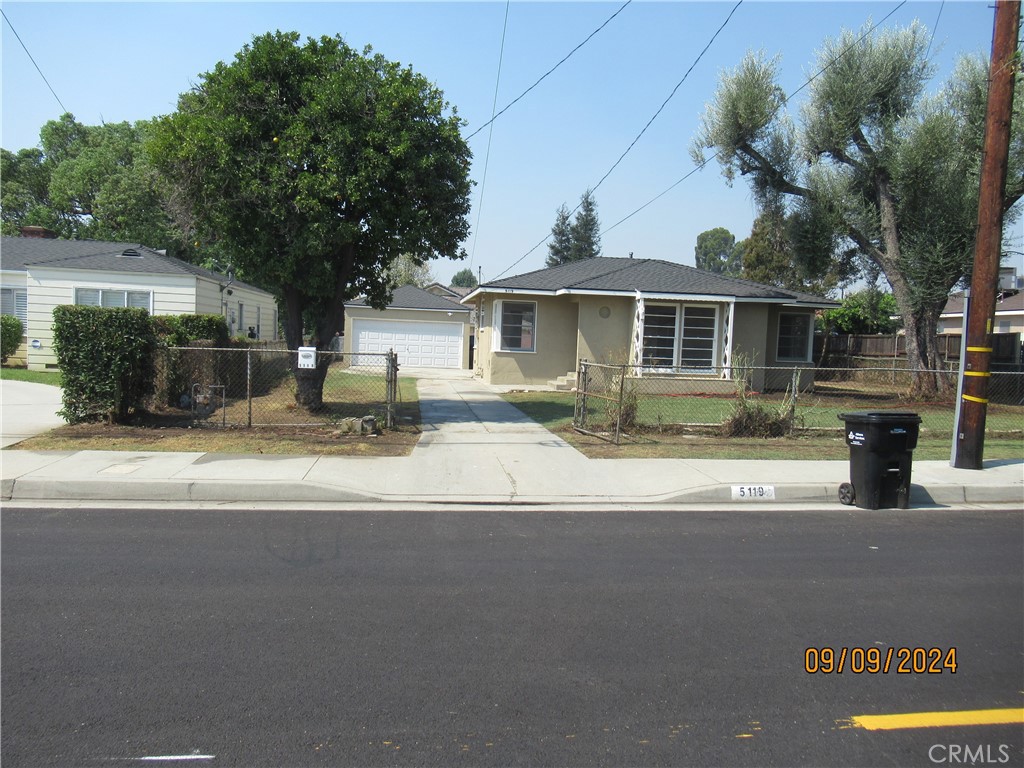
[0,237,261,291]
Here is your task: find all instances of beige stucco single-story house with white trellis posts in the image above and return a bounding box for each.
[463,257,839,392]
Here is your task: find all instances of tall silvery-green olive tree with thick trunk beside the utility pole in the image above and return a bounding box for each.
[692,24,1024,395]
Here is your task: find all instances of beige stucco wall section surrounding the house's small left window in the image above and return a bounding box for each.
[477,295,579,384]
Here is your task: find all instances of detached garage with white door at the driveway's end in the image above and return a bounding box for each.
[342,286,472,369]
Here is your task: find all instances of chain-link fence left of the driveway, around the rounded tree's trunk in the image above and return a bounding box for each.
[151,347,401,431]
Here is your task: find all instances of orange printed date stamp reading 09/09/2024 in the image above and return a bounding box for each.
[804,646,956,675]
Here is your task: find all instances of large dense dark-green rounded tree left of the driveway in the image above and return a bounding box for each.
[151,32,470,408]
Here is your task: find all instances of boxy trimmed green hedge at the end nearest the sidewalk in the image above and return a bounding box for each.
[53,305,157,424]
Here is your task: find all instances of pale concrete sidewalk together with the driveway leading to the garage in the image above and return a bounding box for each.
[2,377,1024,509]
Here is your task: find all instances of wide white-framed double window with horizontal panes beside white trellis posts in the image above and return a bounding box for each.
[643,304,718,373]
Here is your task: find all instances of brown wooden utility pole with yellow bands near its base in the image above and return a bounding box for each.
[953,0,1021,469]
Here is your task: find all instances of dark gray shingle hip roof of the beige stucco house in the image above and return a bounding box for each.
[480,257,838,306]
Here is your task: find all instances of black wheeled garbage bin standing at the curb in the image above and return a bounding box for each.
[839,411,921,509]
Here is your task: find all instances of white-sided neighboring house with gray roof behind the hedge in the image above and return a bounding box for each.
[0,237,278,370]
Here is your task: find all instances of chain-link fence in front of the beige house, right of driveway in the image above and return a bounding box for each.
[572,360,1024,443]
